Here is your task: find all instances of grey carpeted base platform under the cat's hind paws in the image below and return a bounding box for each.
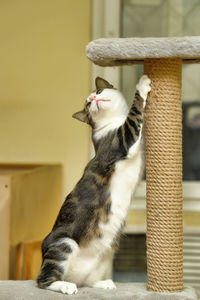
[0,280,197,300]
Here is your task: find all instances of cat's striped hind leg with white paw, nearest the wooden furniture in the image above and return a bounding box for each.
[37,238,79,295]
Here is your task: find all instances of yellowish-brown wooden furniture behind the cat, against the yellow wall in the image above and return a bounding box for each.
[0,164,62,279]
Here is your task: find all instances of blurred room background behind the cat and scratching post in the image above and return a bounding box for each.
[0,0,200,296]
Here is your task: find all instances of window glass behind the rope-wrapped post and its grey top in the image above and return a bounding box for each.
[121,0,200,180]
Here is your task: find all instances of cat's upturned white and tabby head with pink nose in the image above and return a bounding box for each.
[73,77,128,129]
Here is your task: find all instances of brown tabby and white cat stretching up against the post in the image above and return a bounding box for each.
[37,75,151,294]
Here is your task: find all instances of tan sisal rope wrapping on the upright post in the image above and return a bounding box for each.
[144,58,183,292]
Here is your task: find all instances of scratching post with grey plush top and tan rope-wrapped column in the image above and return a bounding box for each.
[87,37,200,300]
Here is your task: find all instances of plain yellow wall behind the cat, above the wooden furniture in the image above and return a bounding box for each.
[0,0,91,193]
